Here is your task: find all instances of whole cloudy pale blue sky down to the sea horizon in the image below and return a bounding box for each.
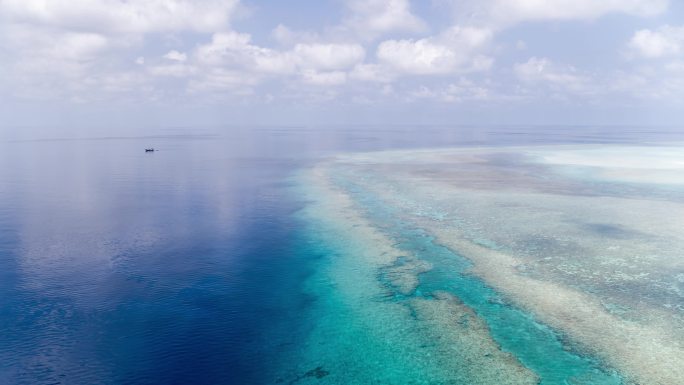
[0,0,684,128]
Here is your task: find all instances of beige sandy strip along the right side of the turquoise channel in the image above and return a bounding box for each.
[434,229,684,385]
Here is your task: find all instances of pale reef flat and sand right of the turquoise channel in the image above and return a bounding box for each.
[324,146,684,385]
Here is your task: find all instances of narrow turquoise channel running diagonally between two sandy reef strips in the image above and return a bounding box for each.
[312,175,623,385]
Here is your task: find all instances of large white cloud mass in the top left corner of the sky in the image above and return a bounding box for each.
[0,0,238,100]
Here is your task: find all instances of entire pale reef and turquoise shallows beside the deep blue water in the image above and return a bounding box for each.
[303,145,684,385]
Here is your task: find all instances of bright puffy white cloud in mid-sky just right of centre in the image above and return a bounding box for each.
[377,26,492,75]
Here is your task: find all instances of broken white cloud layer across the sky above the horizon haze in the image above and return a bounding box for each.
[0,0,684,123]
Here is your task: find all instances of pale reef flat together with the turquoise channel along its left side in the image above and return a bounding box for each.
[312,143,684,384]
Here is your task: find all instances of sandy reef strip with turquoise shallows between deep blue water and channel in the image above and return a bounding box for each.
[284,165,538,384]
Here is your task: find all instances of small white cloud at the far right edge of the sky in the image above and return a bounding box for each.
[628,25,684,59]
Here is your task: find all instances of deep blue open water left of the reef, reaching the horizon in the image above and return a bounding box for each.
[0,126,681,384]
